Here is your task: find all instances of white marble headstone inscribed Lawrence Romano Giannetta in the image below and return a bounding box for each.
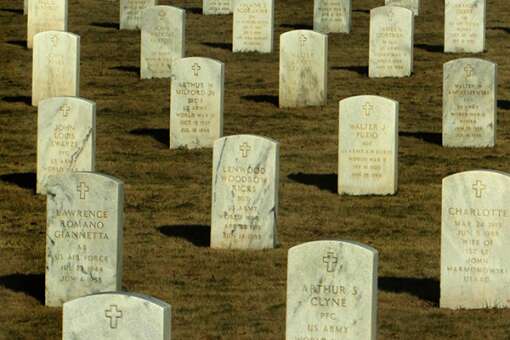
[46,172,124,306]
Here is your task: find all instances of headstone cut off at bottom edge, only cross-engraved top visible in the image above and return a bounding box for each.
[62,292,171,340]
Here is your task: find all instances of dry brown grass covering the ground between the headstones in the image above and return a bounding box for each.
[0,0,510,339]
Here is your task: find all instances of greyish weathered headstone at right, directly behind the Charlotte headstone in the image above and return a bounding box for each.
[443,58,497,147]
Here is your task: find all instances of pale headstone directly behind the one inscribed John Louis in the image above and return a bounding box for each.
[32,31,80,106]
